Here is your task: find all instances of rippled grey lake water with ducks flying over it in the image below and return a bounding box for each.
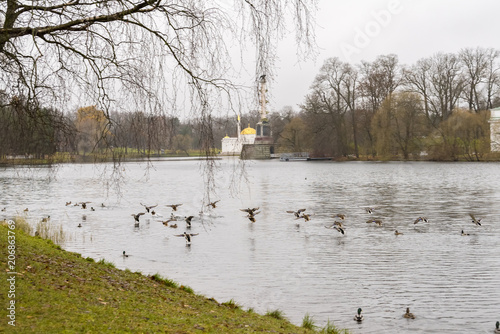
[0,158,500,333]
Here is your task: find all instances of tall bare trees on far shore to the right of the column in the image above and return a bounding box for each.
[292,47,500,160]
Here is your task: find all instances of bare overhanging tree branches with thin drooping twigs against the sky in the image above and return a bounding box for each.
[0,0,316,198]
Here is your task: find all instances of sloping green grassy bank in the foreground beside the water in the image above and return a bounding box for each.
[0,225,350,333]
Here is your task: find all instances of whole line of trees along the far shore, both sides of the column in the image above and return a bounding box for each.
[0,48,500,160]
